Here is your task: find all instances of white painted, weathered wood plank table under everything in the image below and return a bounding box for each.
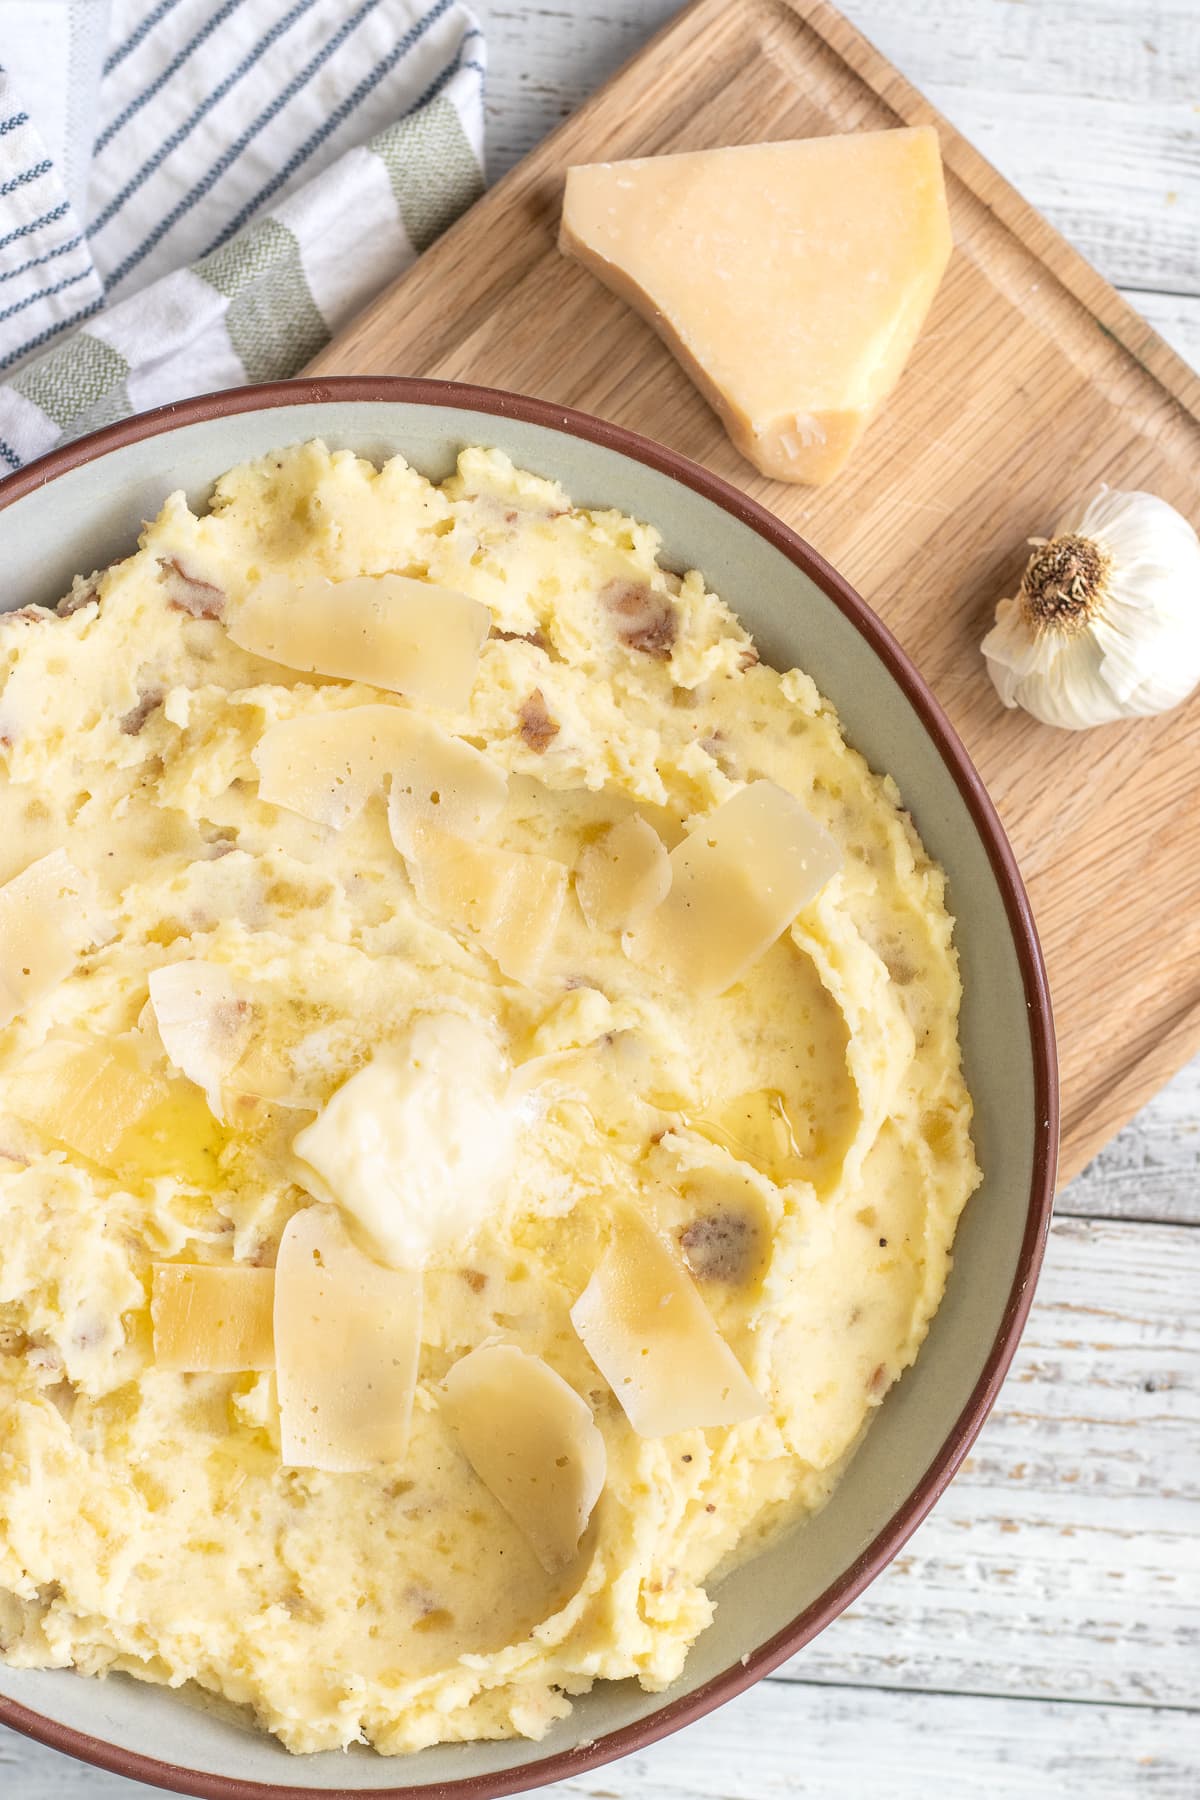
[0,0,1200,1800]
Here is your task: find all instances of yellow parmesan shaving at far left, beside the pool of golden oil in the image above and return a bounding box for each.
[5,1039,167,1168]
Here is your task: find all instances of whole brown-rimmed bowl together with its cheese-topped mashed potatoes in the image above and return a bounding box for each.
[0,380,1056,1800]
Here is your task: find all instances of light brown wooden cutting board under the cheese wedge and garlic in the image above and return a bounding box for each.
[313,0,1200,1179]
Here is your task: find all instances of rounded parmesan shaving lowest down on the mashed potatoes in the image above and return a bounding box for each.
[443,1345,606,1575]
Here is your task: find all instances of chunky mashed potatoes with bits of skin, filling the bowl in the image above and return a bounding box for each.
[0,443,979,1753]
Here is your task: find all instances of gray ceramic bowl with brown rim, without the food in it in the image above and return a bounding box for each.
[0,380,1058,1800]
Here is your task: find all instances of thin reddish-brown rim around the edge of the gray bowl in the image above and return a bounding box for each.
[0,376,1058,1800]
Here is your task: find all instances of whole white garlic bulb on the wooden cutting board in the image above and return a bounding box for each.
[982,488,1200,731]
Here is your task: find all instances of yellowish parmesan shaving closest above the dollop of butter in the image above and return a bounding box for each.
[408,830,567,986]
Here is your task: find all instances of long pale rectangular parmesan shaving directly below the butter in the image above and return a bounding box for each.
[275,1206,421,1472]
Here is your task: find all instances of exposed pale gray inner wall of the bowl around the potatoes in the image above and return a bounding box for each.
[0,400,1036,1793]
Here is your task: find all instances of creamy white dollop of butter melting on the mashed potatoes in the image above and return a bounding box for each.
[291,1013,520,1269]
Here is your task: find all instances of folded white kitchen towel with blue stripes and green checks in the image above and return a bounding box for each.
[0,0,484,473]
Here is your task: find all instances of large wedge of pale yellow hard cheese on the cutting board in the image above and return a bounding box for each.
[560,126,952,486]
